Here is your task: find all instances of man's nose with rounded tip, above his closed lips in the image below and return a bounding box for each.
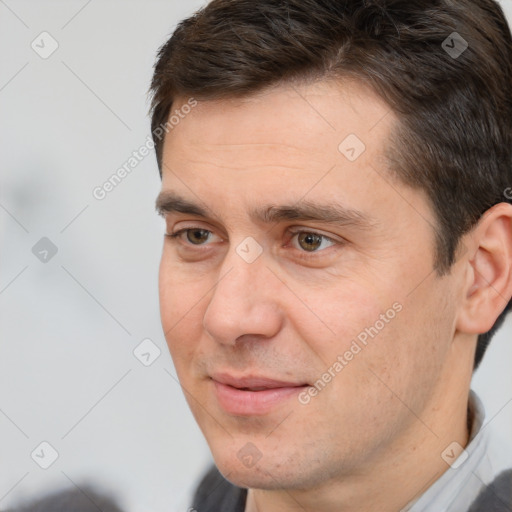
[203,242,283,345]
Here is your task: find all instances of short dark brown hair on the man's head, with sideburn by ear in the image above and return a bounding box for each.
[151,0,512,368]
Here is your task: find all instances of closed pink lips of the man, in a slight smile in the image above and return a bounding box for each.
[211,374,308,416]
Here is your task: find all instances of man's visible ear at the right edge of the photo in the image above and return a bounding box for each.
[456,203,512,334]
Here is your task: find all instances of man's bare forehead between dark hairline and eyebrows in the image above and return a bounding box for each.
[156,82,430,228]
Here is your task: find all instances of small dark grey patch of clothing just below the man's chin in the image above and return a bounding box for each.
[192,466,247,512]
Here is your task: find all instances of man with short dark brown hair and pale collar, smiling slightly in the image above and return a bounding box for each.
[152,0,512,512]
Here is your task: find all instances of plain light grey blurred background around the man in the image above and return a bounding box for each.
[0,0,512,512]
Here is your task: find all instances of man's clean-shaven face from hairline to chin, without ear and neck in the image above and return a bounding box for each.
[160,83,459,489]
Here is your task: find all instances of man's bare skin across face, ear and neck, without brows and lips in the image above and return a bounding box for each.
[155,82,512,512]
